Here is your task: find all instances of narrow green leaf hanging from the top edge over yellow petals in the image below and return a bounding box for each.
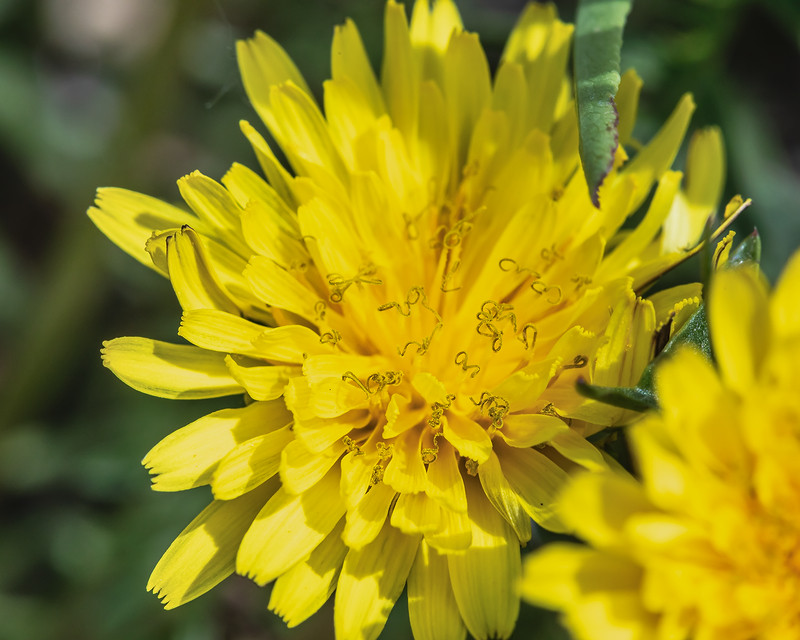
[575,0,631,207]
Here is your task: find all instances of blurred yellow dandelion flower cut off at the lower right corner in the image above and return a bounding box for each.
[523,252,800,640]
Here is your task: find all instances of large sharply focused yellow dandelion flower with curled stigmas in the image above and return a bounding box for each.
[89,0,736,639]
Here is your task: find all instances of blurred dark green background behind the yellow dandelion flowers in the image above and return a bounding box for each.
[0,0,800,640]
